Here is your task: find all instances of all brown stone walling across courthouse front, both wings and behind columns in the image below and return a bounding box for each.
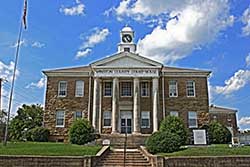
[44,74,209,140]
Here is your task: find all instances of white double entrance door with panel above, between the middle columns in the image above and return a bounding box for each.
[121,111,132,133]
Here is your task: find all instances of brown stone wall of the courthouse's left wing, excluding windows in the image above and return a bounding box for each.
[44,77,89,140]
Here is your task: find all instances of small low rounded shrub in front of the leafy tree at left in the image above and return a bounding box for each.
[27,127,49,142]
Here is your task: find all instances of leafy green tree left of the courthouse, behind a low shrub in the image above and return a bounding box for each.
[9,104,44,140]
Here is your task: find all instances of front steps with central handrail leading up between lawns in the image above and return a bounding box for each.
[96,149,152,167]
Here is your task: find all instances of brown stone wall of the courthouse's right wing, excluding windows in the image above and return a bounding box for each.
[165,77,209,127]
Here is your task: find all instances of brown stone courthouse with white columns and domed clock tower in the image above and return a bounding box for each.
[43,26,210,141]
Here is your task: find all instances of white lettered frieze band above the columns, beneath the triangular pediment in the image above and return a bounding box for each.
[94,69,159,77]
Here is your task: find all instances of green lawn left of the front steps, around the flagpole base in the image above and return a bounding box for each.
[0,142,101,156]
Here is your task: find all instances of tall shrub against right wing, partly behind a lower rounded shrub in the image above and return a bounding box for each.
[160,116,187,145]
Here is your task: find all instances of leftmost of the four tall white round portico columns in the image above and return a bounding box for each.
[92,78,99,130]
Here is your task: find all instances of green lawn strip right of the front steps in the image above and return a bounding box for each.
[159,144,250,156]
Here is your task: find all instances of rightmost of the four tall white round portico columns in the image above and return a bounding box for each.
[153,78,159,132]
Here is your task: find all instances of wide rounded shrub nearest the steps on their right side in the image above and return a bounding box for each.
[146,131,181,154]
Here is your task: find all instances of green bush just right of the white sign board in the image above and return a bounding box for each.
[204,121,232,144]
